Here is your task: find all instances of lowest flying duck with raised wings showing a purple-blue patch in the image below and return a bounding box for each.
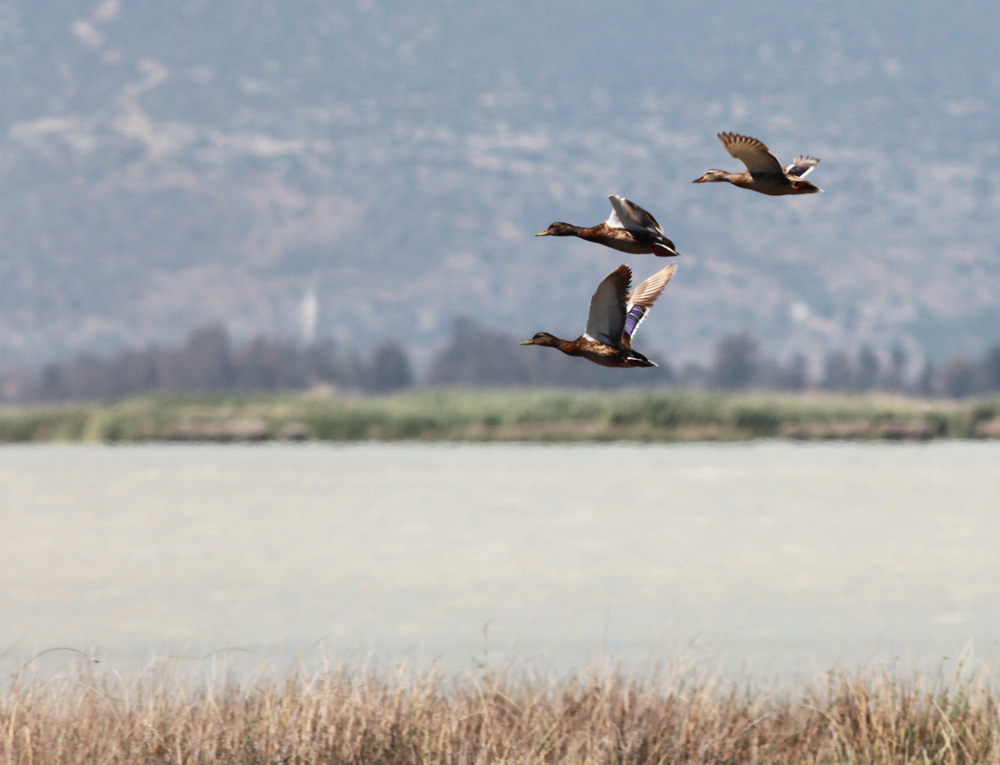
[521,264,677,367]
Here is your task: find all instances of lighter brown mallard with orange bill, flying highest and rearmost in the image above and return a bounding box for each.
[692,133,823,197]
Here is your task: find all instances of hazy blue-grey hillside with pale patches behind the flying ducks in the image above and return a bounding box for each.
[0,0,1000,384]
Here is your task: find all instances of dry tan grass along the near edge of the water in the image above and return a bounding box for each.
[0,656,1000,765]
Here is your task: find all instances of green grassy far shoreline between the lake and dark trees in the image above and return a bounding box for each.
[0,391,1000,443]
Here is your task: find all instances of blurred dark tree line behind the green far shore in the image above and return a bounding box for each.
[0,318,1000,403]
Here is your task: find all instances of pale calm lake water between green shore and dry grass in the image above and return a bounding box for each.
[0,442,1000,677]
